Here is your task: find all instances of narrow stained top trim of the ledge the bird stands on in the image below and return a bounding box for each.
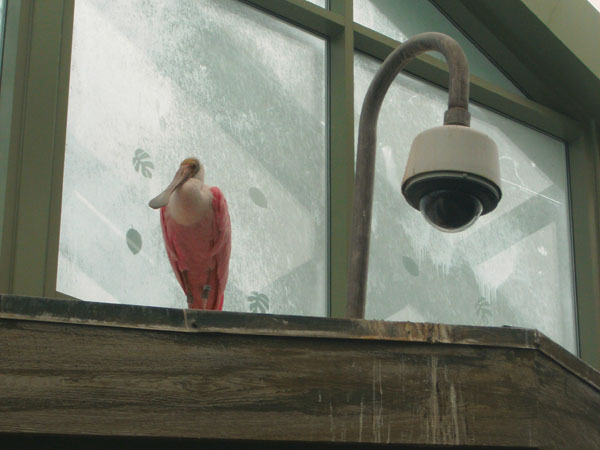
[0,294,600,389]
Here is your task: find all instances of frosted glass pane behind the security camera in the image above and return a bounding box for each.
[354,54,576,352]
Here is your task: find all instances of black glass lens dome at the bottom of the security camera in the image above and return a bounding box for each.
[419,189,483,233]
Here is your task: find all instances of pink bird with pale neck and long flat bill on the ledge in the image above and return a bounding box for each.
[148,158,231,311]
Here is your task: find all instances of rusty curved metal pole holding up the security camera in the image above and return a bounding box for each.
[346,33,471,319]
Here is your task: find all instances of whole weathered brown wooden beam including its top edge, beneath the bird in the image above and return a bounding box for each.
[0,295,600,449]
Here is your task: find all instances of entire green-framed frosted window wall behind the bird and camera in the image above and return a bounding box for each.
[0,0,600,367]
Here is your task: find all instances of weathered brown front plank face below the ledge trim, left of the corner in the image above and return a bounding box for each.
[0,320,536,447]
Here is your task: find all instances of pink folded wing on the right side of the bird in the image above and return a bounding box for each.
[211,187,231,308]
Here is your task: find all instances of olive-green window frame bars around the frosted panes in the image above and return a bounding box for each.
[0,0,600,367]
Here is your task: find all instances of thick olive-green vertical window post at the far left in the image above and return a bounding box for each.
[2,0,70,295]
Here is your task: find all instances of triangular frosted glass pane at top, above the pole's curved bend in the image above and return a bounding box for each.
[354,0,522,95]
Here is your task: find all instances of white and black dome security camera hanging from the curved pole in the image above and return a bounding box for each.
[402,125,502,232]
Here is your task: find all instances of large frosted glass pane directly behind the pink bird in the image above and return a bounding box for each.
[57,0,328,315]
